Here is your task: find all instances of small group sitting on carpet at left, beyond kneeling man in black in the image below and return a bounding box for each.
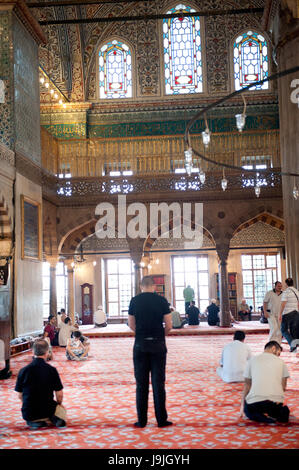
[43,309,90,361]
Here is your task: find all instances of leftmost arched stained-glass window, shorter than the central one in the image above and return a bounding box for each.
[99,40,132,99]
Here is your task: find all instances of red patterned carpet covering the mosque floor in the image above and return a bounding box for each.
[0,333,299,449]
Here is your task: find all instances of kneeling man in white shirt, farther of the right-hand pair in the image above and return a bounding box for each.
[217,330,251,383]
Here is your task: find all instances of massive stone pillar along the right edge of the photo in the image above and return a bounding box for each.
[267,0,299,287]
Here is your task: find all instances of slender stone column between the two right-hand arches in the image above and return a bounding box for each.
[217,248,231,327]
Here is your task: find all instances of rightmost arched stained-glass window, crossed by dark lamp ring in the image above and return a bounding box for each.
[233,31,269,90]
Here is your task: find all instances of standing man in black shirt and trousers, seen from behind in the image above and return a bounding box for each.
[128,276,172,428]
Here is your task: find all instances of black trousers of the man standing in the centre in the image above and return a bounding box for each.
[133,339,167,425]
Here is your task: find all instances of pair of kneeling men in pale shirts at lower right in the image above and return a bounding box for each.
[217,330,290,423]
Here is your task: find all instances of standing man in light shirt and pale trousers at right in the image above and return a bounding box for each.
[263,281,282,344]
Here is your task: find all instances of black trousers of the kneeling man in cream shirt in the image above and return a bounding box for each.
[244,400,290,423]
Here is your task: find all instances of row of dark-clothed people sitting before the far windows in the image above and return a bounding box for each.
[170,299,239,329]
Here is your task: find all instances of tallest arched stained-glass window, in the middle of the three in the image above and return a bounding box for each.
[163,4,202,95]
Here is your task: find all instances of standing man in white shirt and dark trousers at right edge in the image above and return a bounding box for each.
[279,277,299,352]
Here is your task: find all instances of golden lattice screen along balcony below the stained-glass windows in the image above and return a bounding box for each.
[42,129,280,178]
